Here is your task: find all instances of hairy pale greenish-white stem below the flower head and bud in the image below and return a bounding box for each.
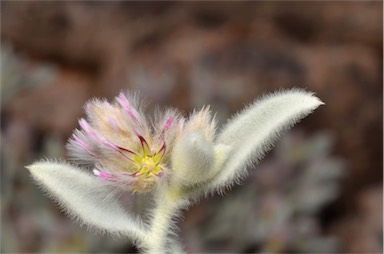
[145,186,184,254]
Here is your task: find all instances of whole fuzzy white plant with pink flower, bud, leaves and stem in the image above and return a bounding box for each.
[27,89,323,253]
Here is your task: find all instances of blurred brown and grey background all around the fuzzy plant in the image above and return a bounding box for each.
[0,1,383,253]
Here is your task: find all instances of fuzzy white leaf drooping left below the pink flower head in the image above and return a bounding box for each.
[27,161,143,240]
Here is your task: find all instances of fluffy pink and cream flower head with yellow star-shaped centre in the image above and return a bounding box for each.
[67,93,183,192]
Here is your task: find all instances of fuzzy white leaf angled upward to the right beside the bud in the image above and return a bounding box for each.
[211,89,324,188]
